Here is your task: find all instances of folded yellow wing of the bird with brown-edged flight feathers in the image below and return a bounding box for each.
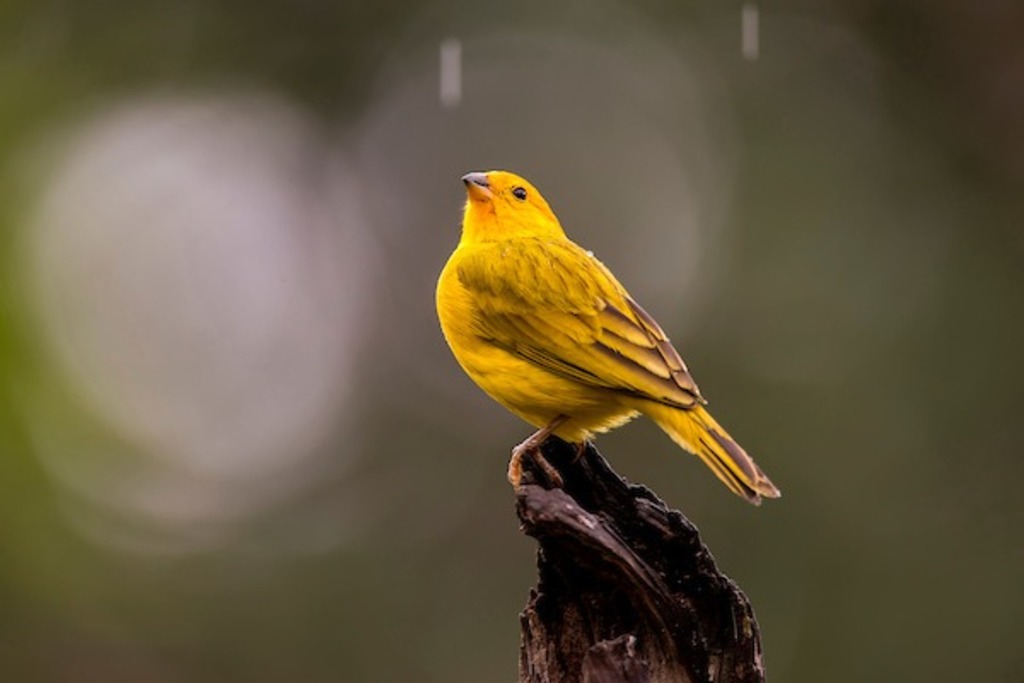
[458,240,703,408]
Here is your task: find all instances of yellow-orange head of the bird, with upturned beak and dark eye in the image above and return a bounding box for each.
[462,171,565,242]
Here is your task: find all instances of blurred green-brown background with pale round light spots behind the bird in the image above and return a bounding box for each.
[0,0,1024,683]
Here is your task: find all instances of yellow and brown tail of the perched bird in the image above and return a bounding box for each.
[641,402,781,505]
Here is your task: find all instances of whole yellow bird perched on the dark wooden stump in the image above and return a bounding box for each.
[437,171,779,504]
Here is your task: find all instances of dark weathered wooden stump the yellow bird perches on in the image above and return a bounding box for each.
[517,438,764,683]
